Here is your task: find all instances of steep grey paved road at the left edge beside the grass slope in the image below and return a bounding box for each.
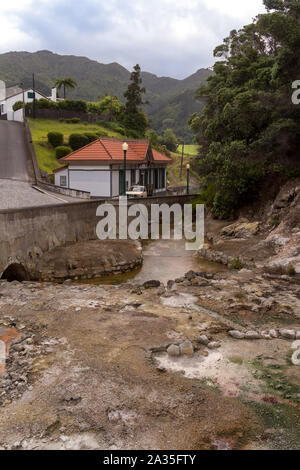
[0,121,30,181]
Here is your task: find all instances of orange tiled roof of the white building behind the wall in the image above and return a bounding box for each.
[60,137,172,163]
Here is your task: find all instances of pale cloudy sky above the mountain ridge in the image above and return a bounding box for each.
[0,0,264,78]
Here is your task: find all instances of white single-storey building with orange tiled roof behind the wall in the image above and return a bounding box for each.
[54,137,172,198]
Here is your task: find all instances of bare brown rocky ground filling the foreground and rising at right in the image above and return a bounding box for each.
[0,179,300,449]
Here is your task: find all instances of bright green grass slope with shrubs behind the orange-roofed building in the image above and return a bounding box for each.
[28,119,123,173]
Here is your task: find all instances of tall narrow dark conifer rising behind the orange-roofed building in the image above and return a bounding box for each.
[123,64,149,137]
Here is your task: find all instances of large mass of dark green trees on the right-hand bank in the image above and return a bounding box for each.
[189,0,300,217]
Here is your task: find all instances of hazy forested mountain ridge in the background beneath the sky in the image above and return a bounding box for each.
[0,51,212,143]
